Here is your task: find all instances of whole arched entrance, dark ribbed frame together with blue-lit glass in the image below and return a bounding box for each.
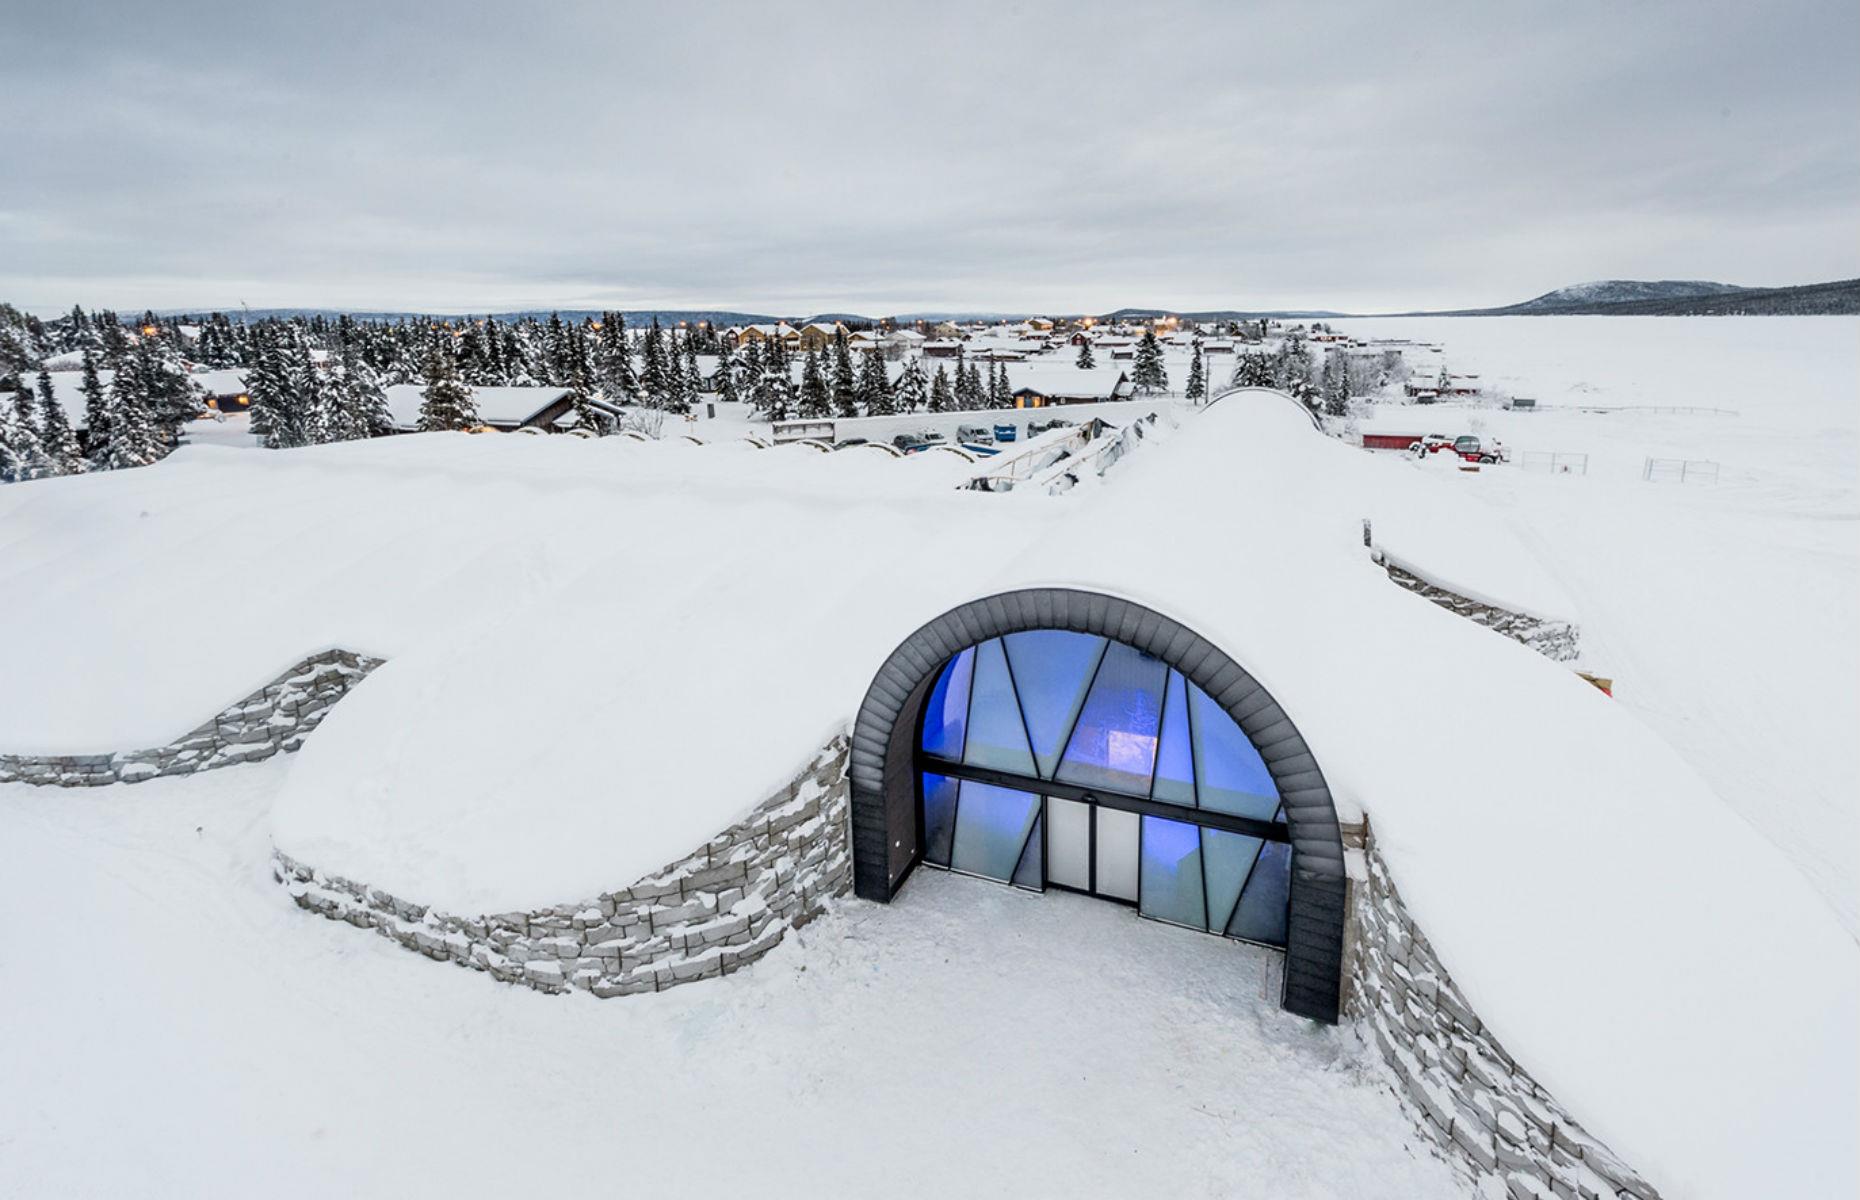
[850,588,1345,1021]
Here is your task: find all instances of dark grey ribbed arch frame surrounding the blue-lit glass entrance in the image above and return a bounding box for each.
[850,588,1345,1023]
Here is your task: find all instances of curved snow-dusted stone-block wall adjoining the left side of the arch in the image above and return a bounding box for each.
[272,737,852,997]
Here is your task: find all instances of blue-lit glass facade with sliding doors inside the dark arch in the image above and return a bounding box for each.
[919,629,1291,945]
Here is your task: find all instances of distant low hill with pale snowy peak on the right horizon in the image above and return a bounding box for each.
[1417,279,1860,316]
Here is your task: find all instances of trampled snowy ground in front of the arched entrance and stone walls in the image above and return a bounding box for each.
[0,761,1464,1200]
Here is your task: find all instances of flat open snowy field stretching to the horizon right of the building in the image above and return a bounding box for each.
[1337,316,1860,936]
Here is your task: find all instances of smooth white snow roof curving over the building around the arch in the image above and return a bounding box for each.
[0,393,1860,1198]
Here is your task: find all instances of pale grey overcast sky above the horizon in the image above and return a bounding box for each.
[0,0,1860,314]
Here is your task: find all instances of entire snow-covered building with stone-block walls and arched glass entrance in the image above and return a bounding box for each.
[0,390,1860,1200]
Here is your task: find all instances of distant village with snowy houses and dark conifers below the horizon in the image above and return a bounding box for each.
[0,305,1481,480]
